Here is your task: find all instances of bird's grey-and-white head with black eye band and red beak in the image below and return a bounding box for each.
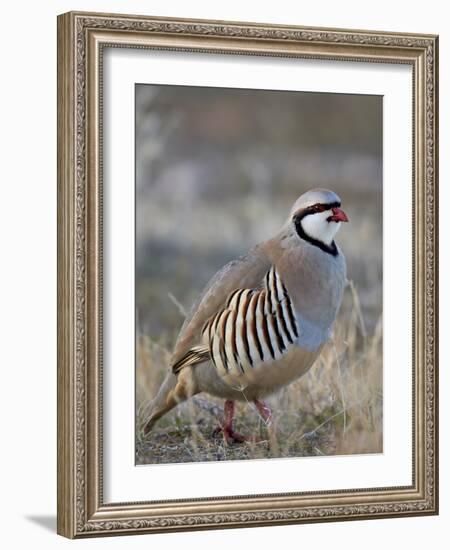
[289,189,348,255]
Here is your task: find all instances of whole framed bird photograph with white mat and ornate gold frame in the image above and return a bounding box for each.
[58,12,438,538]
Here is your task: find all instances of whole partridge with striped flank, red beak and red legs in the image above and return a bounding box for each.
[143,189,349,444]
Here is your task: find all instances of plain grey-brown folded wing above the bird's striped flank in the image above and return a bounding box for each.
[171,247,270,365]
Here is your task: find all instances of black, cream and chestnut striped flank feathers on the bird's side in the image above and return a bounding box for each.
[169,266,298,385]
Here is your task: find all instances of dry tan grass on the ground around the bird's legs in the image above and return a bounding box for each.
[136,283,383,464]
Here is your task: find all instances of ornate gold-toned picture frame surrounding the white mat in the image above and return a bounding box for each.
[58,13,438,538]
